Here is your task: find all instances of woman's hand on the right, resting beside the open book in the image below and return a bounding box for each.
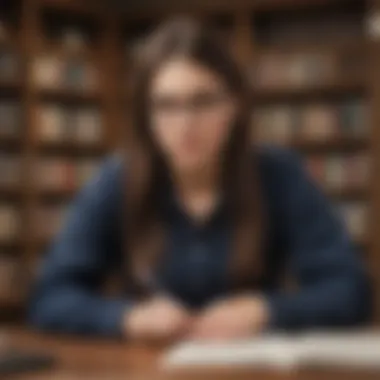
[189,296,269,341]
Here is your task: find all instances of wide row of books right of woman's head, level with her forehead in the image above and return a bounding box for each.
[249,52,365,89]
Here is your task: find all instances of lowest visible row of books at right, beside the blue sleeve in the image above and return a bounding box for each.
[336,202,369,241]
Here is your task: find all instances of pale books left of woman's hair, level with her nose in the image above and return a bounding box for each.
[37,105,103,143]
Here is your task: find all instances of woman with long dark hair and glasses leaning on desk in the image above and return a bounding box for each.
[30,19,371,340]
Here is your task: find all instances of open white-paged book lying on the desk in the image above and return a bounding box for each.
[162,331,380,373]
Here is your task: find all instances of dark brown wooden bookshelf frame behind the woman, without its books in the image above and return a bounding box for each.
[0,0,380,321]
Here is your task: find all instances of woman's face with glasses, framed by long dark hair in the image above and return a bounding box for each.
[150,58,236,171]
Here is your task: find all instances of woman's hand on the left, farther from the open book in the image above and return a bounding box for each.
[124,297,191,342]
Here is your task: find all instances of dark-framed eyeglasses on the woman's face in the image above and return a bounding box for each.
[151,92,230,118]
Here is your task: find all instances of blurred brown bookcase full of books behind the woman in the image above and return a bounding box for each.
[0,0,380,320]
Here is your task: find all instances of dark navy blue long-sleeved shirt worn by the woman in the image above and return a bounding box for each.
[29,148,371,336]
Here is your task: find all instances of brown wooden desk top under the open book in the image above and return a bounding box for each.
[2,330,380,380]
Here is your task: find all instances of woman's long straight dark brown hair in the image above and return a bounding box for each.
[126,17,263,296]
